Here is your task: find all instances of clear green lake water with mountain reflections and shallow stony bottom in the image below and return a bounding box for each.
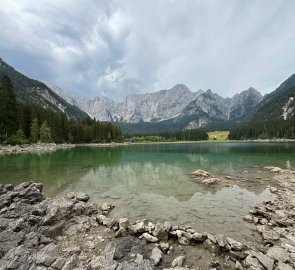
[0,143,295,241]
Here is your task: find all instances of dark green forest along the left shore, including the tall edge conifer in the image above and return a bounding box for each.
[0,76,122,144]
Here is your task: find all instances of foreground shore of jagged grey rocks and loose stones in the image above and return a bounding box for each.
[0,167,295,270]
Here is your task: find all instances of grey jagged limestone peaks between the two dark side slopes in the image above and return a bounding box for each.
[48,84,263,129]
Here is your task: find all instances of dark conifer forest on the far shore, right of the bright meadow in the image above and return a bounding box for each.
[228,120,295,140]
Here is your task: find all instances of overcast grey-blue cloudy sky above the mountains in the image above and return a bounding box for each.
[0,0,295,100]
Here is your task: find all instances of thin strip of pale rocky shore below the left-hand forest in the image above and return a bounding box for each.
[0,143,75,155]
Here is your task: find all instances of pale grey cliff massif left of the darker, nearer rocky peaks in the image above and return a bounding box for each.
[47,84,203,123]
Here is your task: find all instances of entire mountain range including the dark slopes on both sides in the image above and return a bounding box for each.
[0,58,295,133]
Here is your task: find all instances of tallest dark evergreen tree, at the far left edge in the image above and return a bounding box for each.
[0,76,17,138]
